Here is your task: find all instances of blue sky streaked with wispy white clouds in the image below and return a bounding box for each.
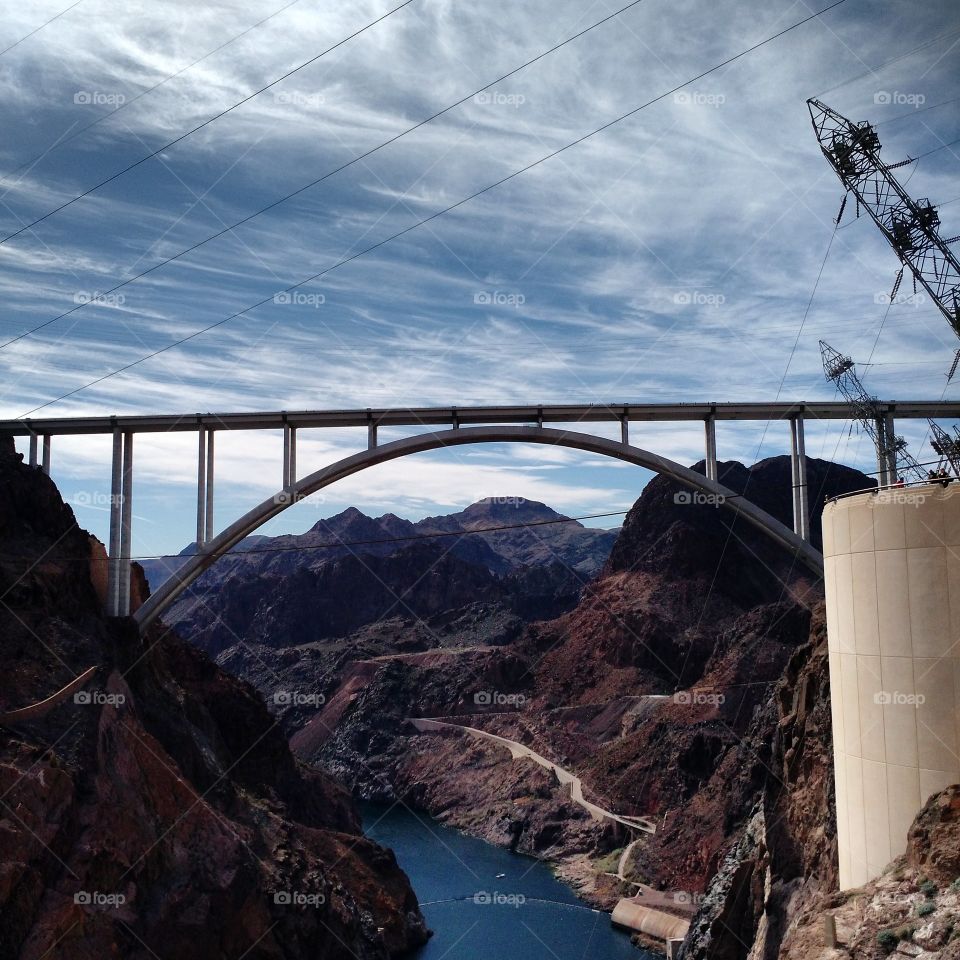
[0,0,960,554]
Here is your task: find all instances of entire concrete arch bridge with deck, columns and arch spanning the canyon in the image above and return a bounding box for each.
[0,401,960,628]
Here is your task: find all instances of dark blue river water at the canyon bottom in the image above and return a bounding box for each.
[360,804,654,960]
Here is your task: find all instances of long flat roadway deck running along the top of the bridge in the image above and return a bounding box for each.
[0,400,960,437]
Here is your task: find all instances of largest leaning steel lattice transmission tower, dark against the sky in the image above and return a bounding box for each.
[807,100,960,344]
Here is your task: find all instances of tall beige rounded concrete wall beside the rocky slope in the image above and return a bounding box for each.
[823,484,960,890]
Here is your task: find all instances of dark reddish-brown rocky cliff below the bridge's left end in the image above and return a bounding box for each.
[0,444,426,960]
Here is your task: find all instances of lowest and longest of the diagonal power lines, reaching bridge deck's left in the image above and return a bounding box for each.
[20,0,847,418]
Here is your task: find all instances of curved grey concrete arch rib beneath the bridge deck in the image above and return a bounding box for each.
[134,426,823,629]
